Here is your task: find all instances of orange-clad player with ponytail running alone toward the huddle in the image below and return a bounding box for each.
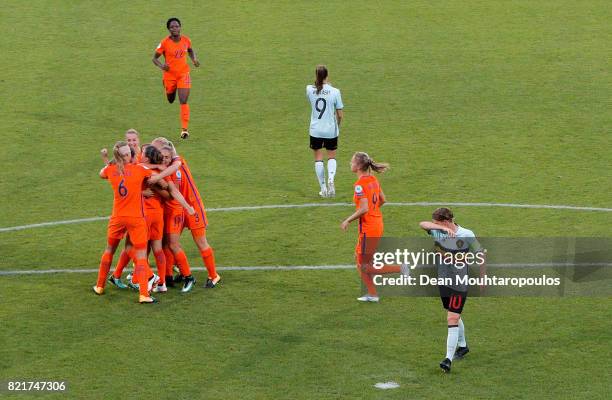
[340,152,403,303]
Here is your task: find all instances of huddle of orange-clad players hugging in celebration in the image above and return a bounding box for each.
[93,129,221,304]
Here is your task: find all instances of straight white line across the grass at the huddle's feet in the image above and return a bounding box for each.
[0,263,612,276]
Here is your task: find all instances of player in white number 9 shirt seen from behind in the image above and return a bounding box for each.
[306,65,344,197]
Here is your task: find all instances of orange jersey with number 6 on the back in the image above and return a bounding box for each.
[102,164,153,217]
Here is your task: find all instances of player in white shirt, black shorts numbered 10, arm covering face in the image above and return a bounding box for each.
[419,208,484,372]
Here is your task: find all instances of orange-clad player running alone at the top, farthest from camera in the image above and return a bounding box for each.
[153,18,200,139]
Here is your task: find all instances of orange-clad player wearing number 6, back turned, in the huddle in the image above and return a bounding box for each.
[93,141,156,303]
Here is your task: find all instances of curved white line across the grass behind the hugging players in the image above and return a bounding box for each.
[0,201,612,233]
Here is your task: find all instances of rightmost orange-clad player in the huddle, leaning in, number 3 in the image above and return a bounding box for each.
[152,138,221,288]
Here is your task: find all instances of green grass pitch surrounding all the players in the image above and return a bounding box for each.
[0,0,612,399]
